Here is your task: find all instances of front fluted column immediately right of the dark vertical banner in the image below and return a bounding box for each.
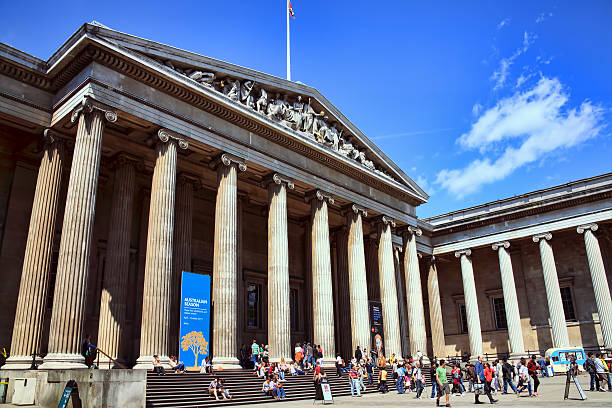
[377,215,403,360]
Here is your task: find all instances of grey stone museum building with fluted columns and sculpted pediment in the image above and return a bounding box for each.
[0,23,612,380]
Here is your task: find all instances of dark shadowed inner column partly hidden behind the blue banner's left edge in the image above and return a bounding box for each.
[169,173,199,357]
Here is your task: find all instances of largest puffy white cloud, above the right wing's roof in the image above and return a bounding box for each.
[435,77,604,198]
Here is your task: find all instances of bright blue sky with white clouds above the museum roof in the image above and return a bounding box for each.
[0,0,612,217]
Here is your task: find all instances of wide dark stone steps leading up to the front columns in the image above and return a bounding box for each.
[147,367,440,408]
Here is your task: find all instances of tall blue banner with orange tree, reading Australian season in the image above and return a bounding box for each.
[179,272,210,368]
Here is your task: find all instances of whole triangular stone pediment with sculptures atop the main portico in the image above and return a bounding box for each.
[82,24,428,202]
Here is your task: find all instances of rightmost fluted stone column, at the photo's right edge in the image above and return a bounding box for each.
[577,224,612,349]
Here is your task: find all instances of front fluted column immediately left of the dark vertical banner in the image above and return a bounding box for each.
[345,204,370,351]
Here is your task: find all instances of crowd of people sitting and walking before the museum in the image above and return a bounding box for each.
[146,339,612,407]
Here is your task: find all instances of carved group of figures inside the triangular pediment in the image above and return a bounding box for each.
[155,59,393,179]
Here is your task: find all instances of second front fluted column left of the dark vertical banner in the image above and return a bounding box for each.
[307,190,336,365]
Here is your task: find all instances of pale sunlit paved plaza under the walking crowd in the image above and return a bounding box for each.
[253,375,612,408]
